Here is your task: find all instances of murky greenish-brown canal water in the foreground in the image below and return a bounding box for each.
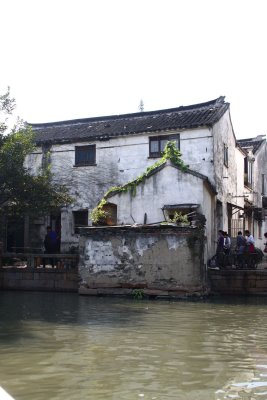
[0,292,267,400]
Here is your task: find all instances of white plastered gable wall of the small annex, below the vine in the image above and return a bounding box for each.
[108,162,210,225]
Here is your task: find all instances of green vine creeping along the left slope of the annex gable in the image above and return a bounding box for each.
[90,141,188,224]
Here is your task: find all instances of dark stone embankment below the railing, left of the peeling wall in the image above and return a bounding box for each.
[0,268,78,292]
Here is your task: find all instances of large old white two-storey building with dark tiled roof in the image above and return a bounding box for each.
[5,97,258,260]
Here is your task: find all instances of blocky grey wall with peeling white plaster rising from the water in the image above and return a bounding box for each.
[79,226,207,297]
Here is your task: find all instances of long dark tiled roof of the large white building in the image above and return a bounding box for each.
[28,97,229,144]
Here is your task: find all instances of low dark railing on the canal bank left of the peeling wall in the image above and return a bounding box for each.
[0,252,79,270]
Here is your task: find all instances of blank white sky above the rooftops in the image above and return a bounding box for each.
[0,0,267,139]
